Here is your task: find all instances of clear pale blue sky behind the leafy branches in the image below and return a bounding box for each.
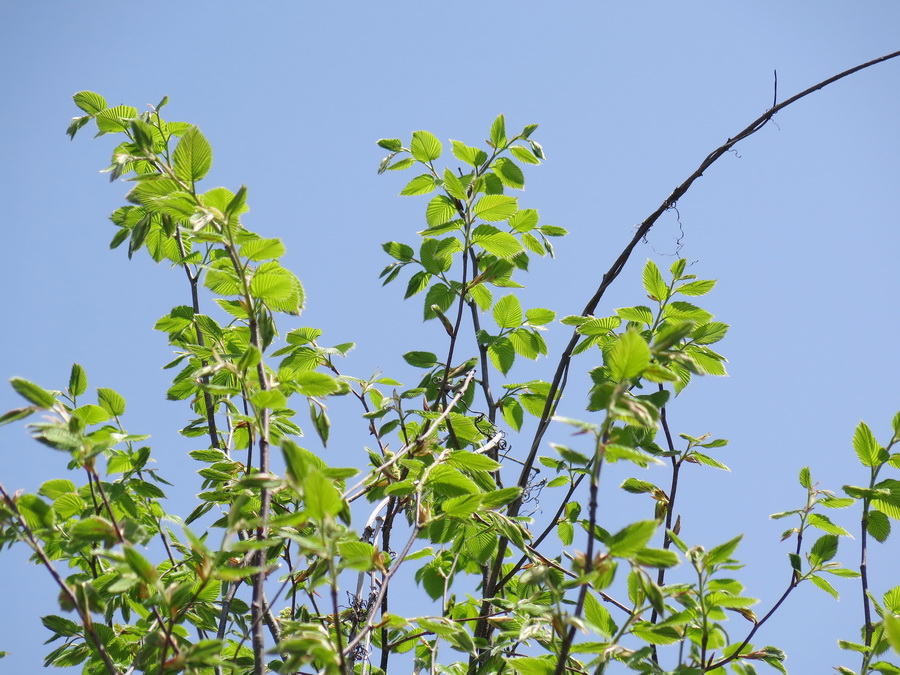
[0,0,900,672]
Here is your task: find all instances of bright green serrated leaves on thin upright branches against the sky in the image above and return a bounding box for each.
[0,91,900,675]
